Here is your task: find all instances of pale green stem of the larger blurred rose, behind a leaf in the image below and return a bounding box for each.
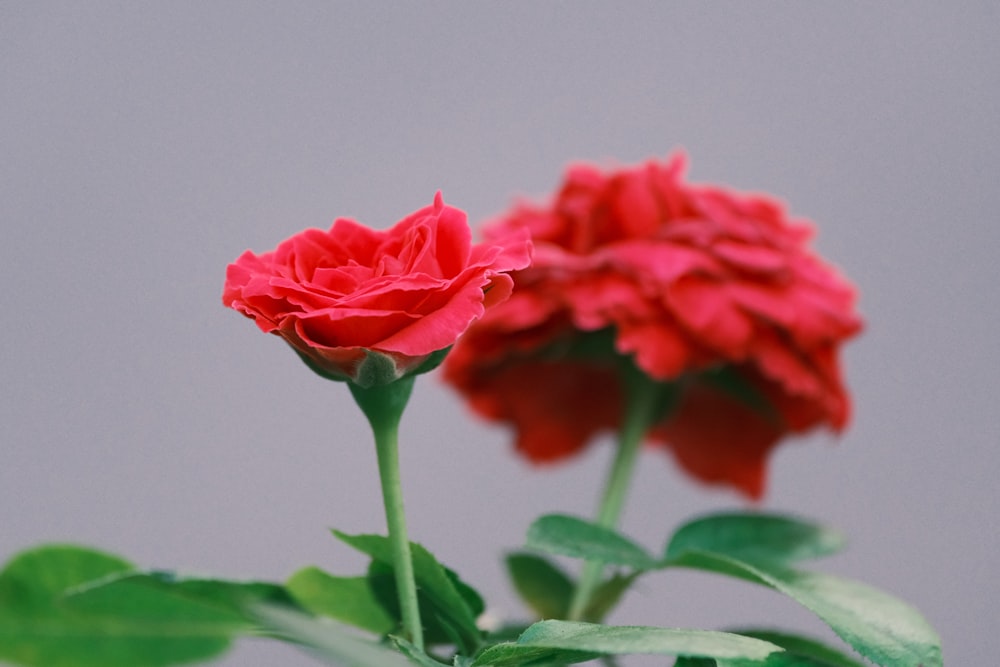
[568,359,669,621]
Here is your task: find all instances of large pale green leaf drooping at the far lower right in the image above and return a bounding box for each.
[666,551,942,667]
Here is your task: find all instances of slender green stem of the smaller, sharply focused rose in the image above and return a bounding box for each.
[348,376,424,651]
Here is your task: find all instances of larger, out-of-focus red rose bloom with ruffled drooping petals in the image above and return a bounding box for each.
[445,156,861,498]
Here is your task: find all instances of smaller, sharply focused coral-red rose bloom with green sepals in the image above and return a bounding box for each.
[222,193,531,386]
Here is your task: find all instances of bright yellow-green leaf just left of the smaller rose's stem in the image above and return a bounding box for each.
[285,567,398,635]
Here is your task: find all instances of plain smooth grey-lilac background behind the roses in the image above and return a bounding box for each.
[0,2,1000,665]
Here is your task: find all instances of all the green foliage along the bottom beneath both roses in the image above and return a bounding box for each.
[0,513,942,667]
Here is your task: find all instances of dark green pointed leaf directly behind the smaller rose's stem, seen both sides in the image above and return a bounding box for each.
[334,531,483,651]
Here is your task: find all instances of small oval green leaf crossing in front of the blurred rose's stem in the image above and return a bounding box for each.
[527,514,659,570]
